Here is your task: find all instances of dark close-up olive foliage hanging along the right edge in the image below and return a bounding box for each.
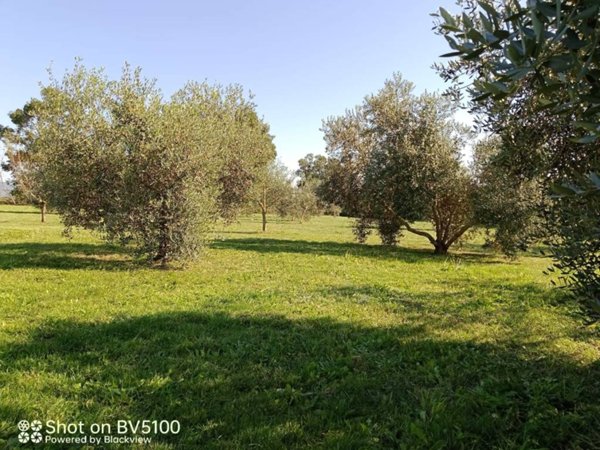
[438,0,600,311]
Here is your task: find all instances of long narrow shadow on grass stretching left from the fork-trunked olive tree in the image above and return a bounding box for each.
[211,238,509,264]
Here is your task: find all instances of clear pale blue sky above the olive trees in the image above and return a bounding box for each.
[0,0,464,171]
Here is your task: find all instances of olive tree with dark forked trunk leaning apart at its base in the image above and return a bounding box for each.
[323,74,488,254]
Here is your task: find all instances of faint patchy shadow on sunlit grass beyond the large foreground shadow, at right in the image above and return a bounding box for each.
[316,279,596,338]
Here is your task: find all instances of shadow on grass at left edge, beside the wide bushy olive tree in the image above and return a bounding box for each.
[0,242,140,270]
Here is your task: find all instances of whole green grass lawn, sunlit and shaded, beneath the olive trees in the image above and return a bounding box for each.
[0,205,600,449]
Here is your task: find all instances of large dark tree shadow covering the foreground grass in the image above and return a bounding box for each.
[0,312,600,449]
